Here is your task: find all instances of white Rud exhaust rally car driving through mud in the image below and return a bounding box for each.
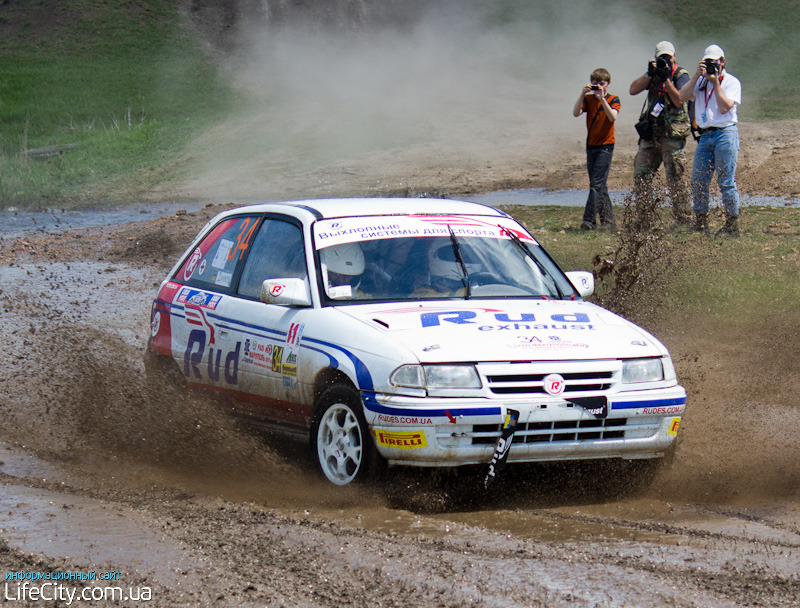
[146,199,686,485]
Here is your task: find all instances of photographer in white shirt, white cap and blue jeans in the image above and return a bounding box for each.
[680,44,742,236]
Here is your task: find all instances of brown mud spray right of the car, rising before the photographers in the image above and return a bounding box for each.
[594,179,800,503]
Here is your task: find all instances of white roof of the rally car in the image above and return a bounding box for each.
[216,198,507,219]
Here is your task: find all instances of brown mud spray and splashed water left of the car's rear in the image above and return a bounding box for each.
[0,263,384,507]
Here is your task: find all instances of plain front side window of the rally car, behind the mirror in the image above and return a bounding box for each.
[238,218,308,299]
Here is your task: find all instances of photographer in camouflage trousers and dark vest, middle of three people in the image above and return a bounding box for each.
[630,40,691,226]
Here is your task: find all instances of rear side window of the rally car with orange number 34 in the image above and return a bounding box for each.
[175,216,260,290]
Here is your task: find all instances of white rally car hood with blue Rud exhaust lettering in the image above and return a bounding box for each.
[339,300,667,363]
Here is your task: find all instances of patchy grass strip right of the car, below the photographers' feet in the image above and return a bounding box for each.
[506,207,800,330]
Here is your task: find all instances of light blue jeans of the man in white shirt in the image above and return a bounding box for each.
[692,125,739,216]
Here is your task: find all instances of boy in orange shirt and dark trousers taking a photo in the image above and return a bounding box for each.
[572,68,621,230]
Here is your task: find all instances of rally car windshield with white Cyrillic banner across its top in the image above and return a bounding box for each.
[314,216,575,304]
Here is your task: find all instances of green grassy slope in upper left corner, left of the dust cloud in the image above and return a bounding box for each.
[0,0,230,207]
